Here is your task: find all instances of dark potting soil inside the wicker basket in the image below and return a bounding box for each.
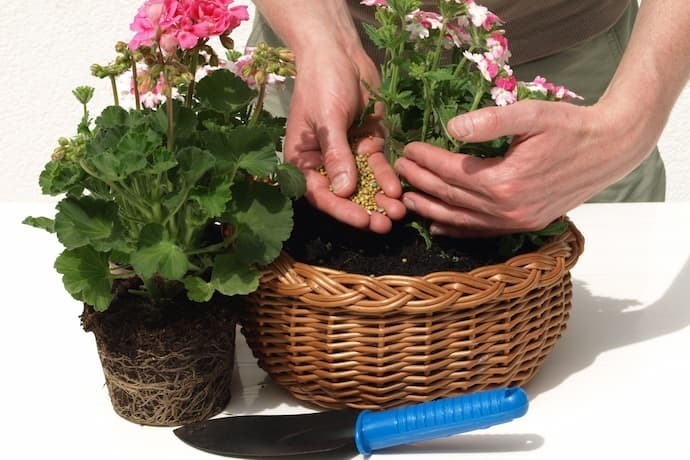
[285,198,507,276]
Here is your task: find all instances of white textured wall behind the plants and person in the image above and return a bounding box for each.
[0,0,690,202]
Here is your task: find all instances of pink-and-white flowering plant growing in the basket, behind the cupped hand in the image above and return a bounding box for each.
[360,0,579,161]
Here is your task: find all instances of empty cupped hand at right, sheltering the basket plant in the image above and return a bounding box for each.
[395,100,658,237]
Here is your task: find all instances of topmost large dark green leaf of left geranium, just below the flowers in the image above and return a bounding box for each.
[196,69,257,113]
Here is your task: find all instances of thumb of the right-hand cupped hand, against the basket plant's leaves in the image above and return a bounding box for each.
[447,101,538,142]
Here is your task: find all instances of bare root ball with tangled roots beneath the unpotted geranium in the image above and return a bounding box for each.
[81,281,237,426]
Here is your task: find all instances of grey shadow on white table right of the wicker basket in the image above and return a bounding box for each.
[525,255,690,397]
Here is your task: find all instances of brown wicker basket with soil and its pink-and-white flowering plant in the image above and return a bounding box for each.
[242,0,583,408]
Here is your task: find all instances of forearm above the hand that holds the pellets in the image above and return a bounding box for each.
[254,0,362,57]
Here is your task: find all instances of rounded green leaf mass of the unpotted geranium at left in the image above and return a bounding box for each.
[24,63,305,311]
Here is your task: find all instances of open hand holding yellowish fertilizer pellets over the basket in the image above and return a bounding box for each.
[284,48,406,233]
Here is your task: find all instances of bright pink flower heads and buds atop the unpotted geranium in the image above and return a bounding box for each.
[92,0,295,109]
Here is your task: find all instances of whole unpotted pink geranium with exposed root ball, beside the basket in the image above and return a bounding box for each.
[25,0,305,425]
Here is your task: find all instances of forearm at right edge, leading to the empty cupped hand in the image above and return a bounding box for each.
[600,0,690,142]
